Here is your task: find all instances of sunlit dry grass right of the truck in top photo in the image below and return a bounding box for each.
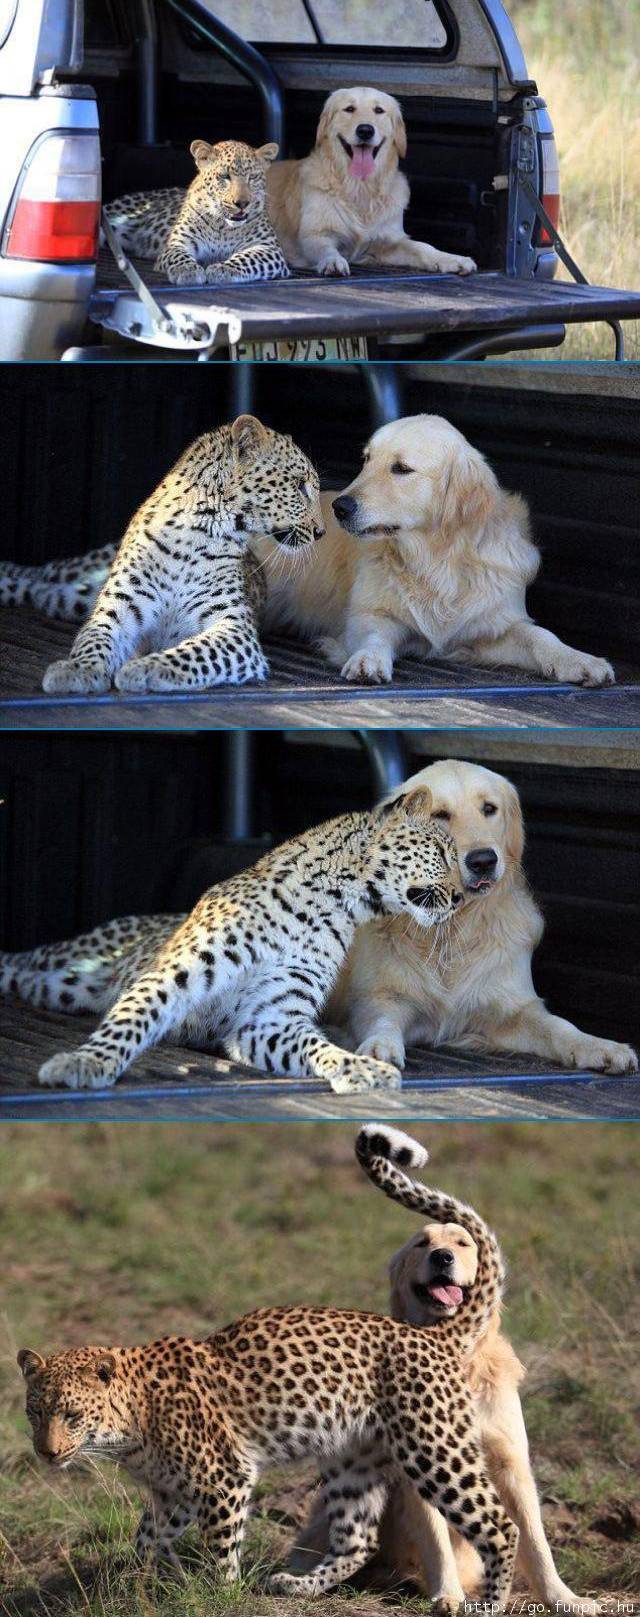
[506,0,640,359]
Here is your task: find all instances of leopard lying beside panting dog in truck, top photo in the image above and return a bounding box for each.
[103,141,291,286]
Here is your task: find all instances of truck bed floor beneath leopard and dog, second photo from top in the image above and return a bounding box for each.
[0,608,640,729]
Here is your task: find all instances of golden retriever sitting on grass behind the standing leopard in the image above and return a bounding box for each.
[289,1125,600,1617]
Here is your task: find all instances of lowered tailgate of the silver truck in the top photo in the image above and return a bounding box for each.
[89,249,640,341]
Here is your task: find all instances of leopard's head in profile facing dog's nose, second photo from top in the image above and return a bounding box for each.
[228,416,325,550]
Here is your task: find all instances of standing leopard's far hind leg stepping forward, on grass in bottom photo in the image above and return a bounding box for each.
[267,1454,388,1598]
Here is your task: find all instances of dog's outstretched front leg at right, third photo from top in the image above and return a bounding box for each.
[486,999,638,1074]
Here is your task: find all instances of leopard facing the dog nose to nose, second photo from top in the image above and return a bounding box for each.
[35,416,325,692]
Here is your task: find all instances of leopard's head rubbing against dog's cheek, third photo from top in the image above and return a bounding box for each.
[368,792,464,927]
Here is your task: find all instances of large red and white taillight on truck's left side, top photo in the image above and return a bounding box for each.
[3,133,100,264]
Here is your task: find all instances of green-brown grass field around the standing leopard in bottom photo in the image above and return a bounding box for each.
[0,1124,640,1617]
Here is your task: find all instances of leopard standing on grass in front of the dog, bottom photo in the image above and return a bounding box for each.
[18,1131,517,1606]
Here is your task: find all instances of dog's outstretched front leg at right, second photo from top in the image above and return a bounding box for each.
[451,618,616,686]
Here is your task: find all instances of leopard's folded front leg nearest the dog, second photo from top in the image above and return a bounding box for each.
[115,608,268,690]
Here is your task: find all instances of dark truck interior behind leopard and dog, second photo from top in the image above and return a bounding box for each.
[0,365,640,723]
